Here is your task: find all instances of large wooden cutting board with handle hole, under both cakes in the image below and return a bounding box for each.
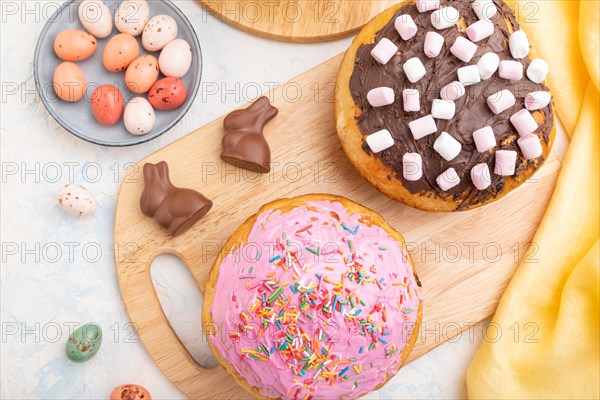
[115,55,560,399]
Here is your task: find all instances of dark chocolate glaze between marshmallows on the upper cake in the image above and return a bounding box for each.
[350,0,553,209]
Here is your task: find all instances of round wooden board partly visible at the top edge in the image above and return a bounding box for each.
[199,0,397,42]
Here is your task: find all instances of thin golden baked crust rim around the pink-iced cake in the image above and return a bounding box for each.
[202,194,423,399]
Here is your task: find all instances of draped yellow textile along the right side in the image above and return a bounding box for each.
[467,0,600,399]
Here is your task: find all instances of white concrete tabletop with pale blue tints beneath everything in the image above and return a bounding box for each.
[0,0,568,399]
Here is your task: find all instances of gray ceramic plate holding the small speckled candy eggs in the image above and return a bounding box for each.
[33,0,202,146]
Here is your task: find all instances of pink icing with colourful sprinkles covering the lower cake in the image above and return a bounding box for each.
[209,201,421,399]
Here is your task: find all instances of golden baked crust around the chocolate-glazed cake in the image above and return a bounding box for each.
[334,1,556,211]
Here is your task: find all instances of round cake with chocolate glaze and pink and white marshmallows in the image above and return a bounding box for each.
[335,0,555,211]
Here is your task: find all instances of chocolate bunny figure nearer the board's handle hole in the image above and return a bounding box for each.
[140,161,213,236]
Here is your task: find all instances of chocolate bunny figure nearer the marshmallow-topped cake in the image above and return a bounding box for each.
[221,96,279,173]
